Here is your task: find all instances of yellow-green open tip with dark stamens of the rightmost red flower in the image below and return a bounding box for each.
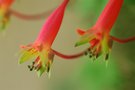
[75,30,112,60]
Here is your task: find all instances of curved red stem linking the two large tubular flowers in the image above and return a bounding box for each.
[52,50,86,59]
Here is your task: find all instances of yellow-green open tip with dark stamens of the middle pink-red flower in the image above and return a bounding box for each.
[19,46,54,77]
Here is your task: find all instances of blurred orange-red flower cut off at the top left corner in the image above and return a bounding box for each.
[0,0,14,29]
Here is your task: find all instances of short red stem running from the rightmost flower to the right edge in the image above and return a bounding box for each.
[110,36,135,43]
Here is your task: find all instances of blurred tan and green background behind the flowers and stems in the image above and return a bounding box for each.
[0,0,135,90]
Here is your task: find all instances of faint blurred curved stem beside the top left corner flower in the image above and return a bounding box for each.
[9,9,54,20]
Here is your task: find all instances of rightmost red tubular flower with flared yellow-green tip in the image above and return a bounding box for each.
[75,0,123,60]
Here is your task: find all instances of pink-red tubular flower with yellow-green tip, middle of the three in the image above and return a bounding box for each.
[20,0,69,76]
